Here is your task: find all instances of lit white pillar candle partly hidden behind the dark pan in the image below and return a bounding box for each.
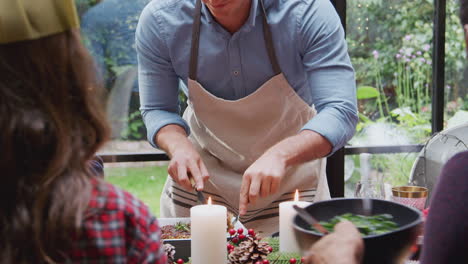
[279,190,310,253]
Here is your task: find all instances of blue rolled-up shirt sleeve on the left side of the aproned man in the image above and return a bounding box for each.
[135,5,190,148]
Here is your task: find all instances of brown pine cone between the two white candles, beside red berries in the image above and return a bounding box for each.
[228,237,270,264]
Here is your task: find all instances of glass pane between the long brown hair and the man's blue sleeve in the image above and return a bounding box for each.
[75,0,154,153]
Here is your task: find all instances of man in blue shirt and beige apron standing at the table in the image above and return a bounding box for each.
[136,0,358,232]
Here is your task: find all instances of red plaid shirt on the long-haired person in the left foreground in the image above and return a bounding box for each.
[68,180,167,264]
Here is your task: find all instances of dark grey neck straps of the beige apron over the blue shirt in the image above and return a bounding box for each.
[189,0,281,80]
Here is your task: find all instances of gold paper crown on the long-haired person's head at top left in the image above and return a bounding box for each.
[0,0,79,44]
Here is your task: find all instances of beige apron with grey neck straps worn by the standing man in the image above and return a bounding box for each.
[161,0,330,235]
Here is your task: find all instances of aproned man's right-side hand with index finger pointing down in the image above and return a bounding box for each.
[239,152,286,215]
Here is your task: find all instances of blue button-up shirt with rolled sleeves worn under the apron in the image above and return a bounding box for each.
[136,0,358,155]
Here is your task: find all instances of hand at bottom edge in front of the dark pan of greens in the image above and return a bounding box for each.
[304,221,364,264]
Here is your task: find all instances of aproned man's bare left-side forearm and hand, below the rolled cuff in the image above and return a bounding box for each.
[155,125,209,191]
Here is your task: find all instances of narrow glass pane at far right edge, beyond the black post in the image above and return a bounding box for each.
[444,0,468,128]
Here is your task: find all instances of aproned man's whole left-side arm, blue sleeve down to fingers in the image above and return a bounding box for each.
[136,4,208,190]
